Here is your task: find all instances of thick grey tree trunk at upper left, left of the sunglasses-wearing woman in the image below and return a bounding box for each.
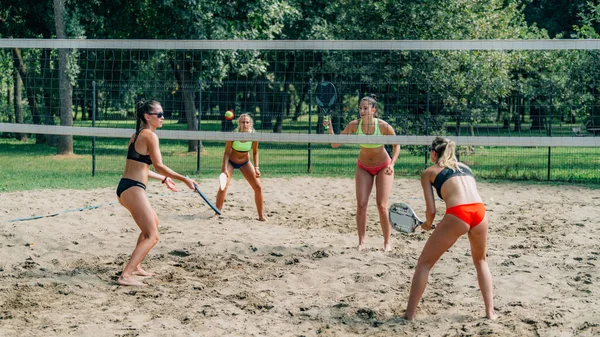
[54,0,73,155]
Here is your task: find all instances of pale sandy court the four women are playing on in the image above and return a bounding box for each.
[0,174,600,336]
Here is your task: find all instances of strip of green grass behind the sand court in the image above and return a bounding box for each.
[0,134,600,192]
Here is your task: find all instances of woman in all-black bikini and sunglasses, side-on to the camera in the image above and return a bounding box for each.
[117,100,196,286]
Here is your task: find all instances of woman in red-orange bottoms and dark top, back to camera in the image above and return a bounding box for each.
[404,137,496,320]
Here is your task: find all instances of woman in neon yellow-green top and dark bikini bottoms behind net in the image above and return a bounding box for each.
[216,114,267,221]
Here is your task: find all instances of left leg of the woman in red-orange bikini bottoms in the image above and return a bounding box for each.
[404,215,469,320]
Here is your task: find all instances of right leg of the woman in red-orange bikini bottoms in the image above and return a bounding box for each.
[469,215,496,319]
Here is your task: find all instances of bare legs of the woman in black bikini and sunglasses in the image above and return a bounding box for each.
[117,187,159,286]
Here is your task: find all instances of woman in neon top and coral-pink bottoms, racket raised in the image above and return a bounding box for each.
[325,95,400,252]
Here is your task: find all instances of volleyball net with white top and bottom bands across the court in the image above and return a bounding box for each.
[0,39,600,183]
